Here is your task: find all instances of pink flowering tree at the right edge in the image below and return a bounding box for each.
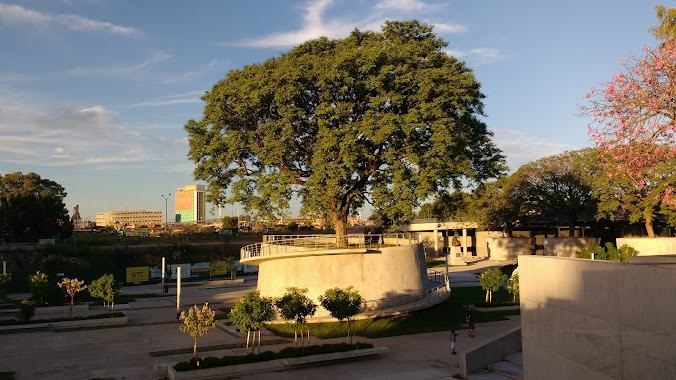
[582,41,676,237]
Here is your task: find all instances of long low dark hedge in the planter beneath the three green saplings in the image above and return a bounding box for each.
[174,343,373,372]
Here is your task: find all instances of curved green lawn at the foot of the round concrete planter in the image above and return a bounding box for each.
[266,287,519,339]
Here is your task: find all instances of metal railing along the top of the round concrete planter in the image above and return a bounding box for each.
[240,233,420,260]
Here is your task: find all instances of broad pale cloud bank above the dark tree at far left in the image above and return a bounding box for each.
[0,92,172,169]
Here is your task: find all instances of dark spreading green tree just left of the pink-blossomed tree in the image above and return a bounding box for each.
[511,149,597,237]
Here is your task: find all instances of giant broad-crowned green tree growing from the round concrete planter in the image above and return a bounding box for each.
[185,21,504,236]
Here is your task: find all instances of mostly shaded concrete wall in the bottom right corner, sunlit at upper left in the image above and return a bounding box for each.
[519,256,676,380]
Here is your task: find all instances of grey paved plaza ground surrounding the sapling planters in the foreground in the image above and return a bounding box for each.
[0,261,520,380]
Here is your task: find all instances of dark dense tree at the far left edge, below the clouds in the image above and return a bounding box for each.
[0,172,73,242]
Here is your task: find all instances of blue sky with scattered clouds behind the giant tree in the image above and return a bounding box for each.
[0,0,664,220]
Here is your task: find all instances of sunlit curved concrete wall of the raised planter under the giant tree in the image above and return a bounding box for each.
[258,244,427,301]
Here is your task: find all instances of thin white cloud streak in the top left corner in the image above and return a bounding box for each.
[0,3,141,36]
